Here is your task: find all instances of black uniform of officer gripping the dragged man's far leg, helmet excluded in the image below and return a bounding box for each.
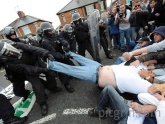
[41,34,74,92]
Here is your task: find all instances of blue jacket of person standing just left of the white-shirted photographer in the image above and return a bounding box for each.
[108,17,119,35]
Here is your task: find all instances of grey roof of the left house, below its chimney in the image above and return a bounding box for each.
[8,15,49,29]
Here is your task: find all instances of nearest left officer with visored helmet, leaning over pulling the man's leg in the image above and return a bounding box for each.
[0,39,61,116]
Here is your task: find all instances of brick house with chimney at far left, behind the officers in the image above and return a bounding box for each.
[0,11,52,39]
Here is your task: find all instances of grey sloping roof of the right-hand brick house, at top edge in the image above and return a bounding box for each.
[57,0,98,15]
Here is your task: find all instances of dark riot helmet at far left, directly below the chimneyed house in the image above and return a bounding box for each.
[3,26,17,40]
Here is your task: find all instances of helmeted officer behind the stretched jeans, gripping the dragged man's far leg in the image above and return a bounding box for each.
[40,22,74,93]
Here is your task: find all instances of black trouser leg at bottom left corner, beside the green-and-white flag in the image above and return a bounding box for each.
[0,94,14,121]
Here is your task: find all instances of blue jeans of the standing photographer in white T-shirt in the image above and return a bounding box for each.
[119,28,130,51]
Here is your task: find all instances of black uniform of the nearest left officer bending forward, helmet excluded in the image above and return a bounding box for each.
[0,42,56,104]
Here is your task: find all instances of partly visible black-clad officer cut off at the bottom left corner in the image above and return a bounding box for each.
[0,94,27,124]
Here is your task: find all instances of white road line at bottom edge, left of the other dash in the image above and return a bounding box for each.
[30,113,56,124]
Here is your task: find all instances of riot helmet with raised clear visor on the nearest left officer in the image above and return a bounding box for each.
[0,39,21,59]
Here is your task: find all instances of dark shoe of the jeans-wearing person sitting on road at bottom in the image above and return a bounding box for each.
[88,108,106,119]
